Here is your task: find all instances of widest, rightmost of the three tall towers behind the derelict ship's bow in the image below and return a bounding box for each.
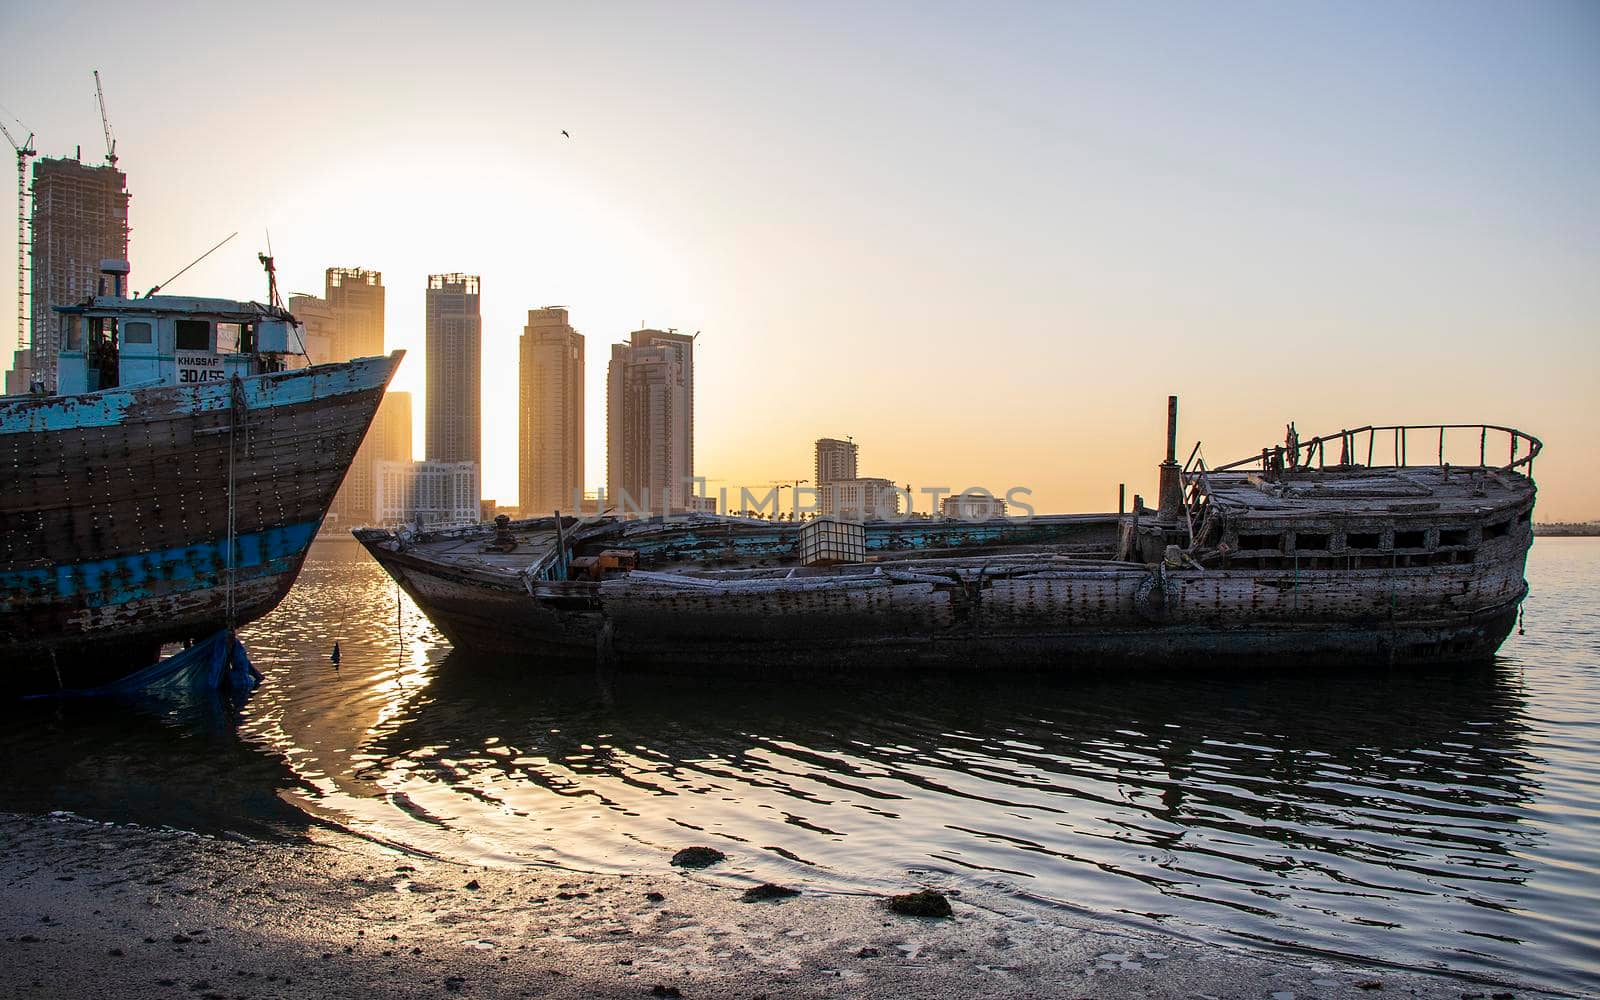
[605,330,694,514]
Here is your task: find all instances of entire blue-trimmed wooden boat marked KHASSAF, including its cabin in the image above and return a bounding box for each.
[0,259,403,691]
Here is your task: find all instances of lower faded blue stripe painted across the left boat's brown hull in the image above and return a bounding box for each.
[0,518,322,611]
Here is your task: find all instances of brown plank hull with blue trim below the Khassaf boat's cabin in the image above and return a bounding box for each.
[0,354,400,688]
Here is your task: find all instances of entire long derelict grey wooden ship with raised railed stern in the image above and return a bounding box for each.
[357,398,1541,672]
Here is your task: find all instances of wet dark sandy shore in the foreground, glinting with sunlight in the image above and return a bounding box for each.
[0,813,1549,1000]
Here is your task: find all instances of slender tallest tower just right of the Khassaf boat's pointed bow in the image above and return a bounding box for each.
[424,274,483,476]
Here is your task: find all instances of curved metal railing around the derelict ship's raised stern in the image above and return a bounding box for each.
[1209,424,1544,482]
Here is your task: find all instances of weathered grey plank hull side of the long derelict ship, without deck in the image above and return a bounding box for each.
[360,515,1526,672]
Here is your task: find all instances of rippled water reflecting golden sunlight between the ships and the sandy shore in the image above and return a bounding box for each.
[0,539,1600,990]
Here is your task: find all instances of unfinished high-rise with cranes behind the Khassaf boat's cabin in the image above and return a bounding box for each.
[25,157,130,392]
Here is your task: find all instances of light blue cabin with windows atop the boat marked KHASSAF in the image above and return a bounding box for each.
[54,260,306,395]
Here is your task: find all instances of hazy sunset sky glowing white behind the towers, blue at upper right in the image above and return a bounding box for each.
[0,0,1600,520]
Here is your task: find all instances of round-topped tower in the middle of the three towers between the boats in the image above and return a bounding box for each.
[517,307,584,515]
